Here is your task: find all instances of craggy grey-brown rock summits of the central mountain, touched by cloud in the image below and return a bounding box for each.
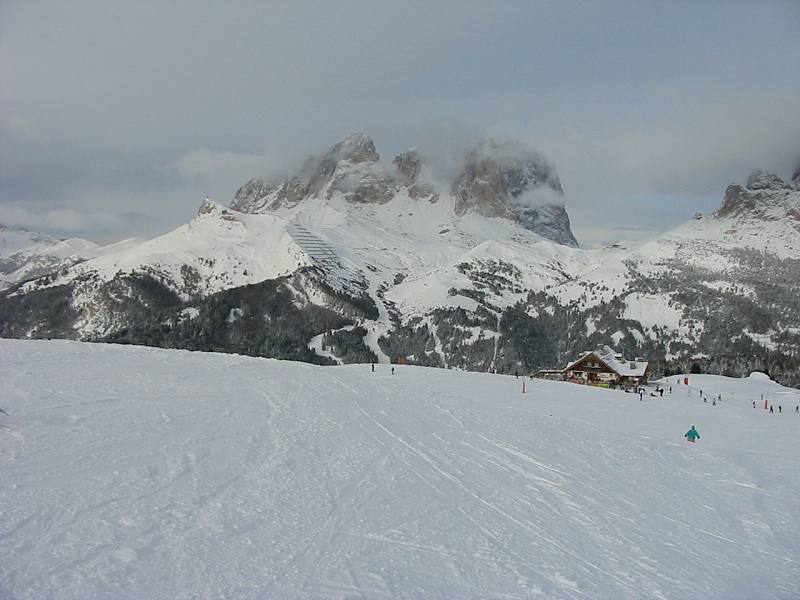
[231,133,578,247]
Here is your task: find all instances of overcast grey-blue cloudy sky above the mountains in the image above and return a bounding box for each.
[0,0,800,246]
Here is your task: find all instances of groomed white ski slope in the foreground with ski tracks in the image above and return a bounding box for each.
[0,340,800,600]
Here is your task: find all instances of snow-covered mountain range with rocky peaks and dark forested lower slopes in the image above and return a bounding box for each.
[0,133,800,385]
